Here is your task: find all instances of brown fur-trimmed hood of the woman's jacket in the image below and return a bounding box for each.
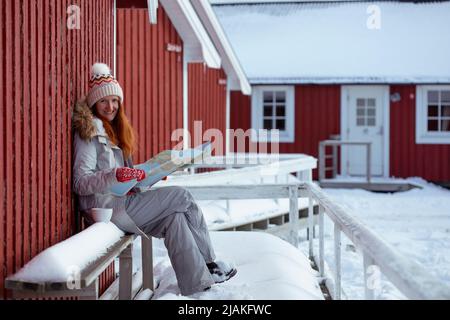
[72,99,106,140]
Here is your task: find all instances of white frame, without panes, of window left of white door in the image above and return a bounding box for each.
[251,86,295,143]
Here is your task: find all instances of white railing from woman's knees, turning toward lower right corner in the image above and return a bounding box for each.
[159,182,450,300]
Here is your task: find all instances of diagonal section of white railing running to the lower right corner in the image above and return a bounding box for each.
[303,183,450,299]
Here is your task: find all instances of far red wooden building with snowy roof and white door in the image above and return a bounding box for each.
[212,0,450,183]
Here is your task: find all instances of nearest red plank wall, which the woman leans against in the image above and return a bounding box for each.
[0,0,114,298]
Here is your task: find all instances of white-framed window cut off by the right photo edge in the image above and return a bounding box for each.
[416,86,450,144]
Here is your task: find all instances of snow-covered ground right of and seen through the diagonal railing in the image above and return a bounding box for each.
[300,178,450,299]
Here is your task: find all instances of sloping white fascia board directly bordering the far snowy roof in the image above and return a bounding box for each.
[191,0,252,95]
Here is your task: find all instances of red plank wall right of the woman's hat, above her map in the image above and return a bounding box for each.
[117,7,183,163]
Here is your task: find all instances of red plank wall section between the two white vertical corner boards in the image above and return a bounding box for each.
[188,63,227,155]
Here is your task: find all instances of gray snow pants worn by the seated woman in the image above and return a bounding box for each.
[126,187,215,295]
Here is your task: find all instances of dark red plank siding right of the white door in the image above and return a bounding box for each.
[390,85,450,182]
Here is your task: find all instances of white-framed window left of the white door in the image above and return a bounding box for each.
[252,86,294,142]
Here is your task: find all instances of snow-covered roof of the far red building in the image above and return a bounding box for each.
[212,0,450,84]
